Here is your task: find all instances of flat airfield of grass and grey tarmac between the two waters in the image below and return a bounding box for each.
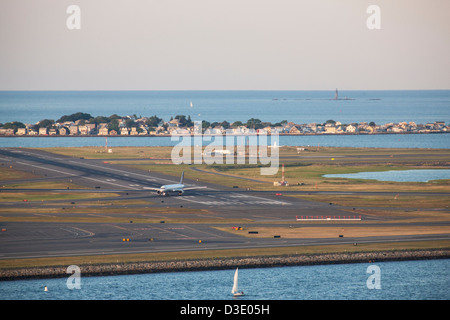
[0,147,450,273]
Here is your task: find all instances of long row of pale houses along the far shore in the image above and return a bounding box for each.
[0,119,450,136]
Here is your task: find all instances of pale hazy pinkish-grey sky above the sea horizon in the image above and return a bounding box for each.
[0,0,450,90]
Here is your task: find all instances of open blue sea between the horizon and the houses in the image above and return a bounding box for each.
[0,88,450,124]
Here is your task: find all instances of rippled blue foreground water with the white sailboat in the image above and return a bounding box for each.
[0,259,450,301]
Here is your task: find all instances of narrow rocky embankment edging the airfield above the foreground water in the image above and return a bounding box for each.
[0,248,450,281]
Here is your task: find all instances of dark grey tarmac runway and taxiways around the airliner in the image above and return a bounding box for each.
[0,148,450,259]
